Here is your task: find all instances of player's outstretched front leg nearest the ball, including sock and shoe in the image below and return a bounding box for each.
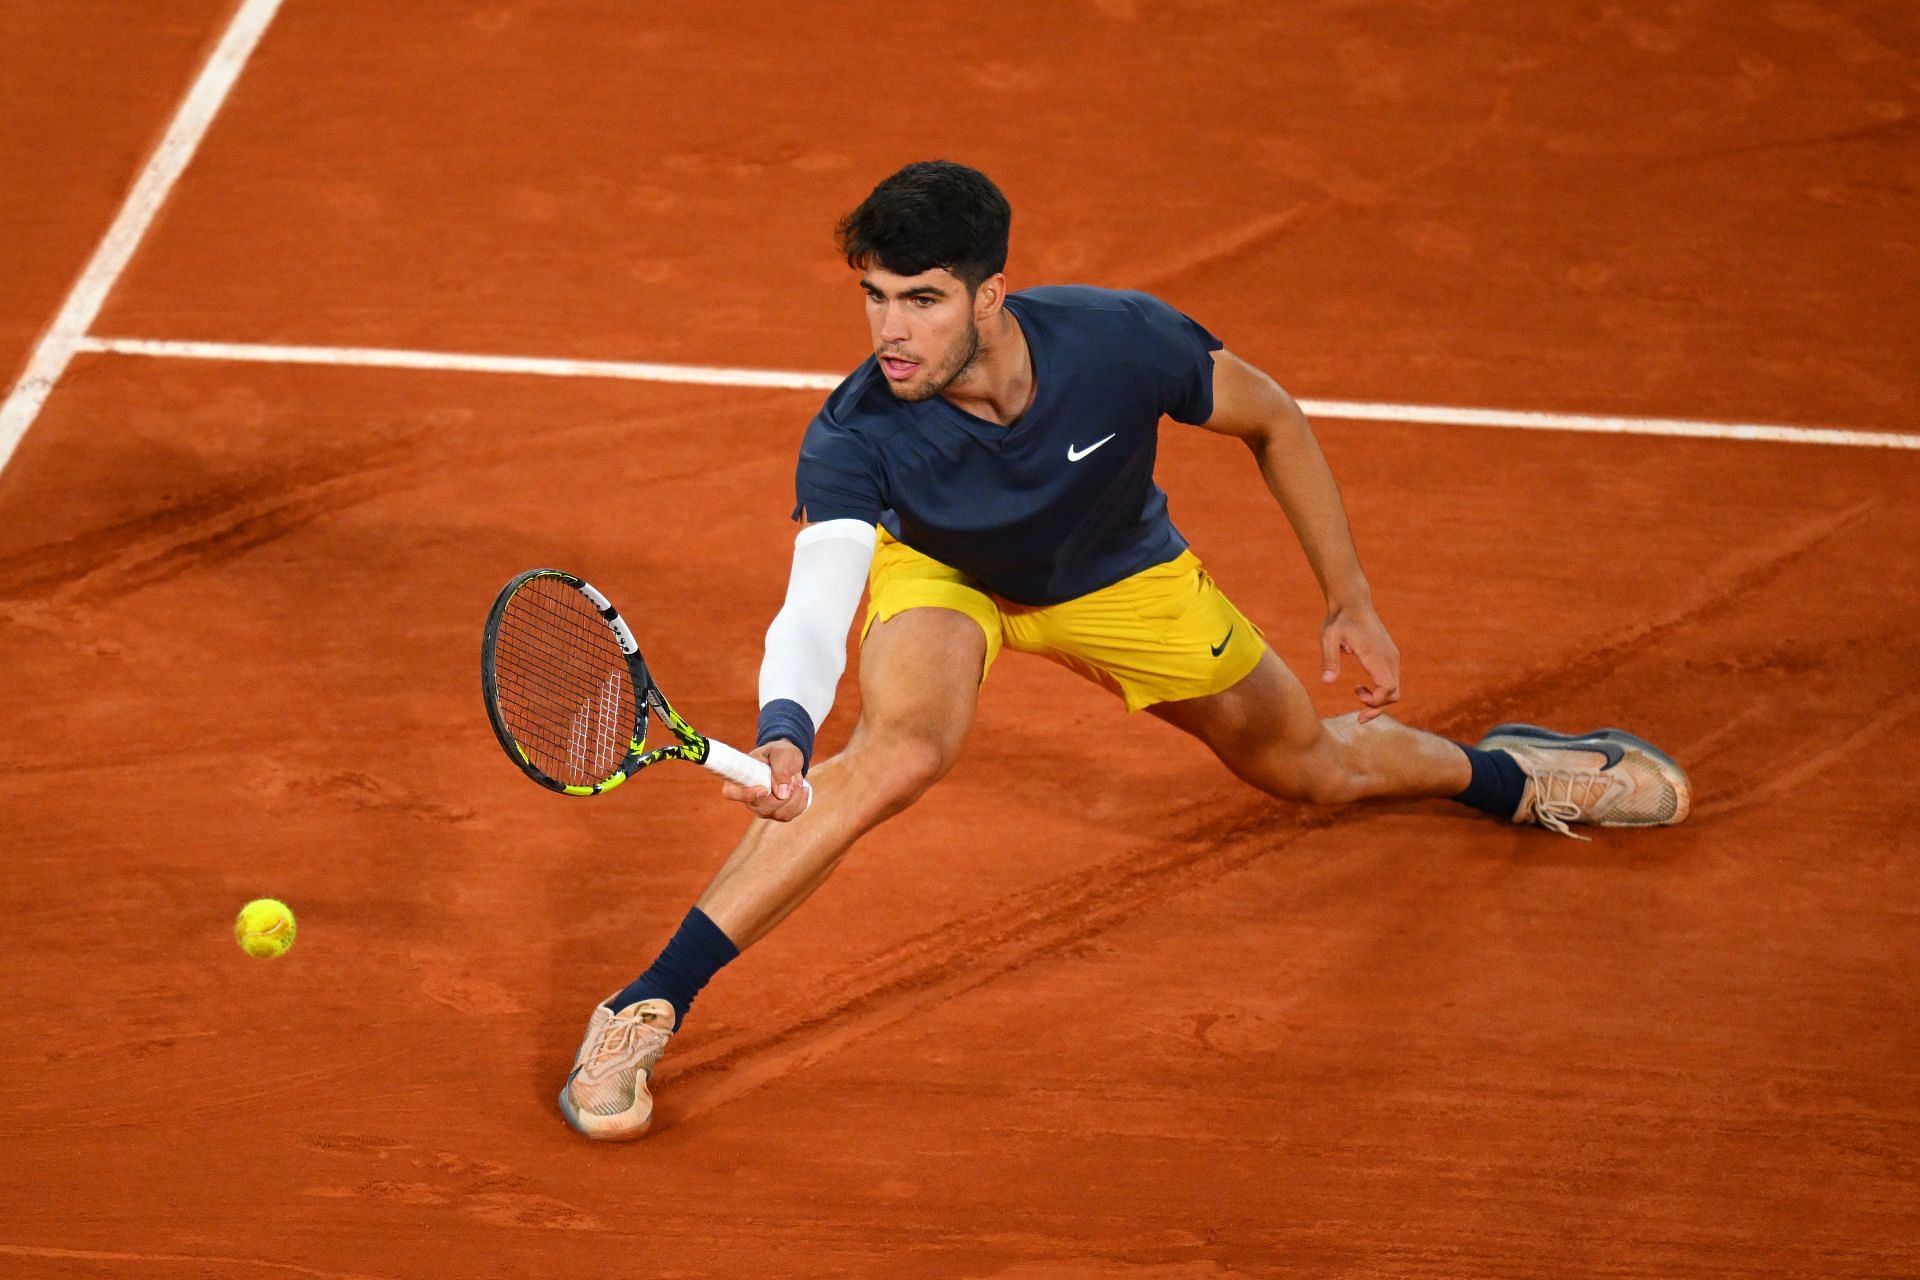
[561,608,987,1140]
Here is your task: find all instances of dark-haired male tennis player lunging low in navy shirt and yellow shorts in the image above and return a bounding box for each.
[561,161,1690,1138]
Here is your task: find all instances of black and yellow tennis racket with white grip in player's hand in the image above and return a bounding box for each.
[480,568,802,796]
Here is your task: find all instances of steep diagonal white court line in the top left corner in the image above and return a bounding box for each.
[0,0,280,470]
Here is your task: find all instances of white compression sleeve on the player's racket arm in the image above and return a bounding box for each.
[760,520,876,729]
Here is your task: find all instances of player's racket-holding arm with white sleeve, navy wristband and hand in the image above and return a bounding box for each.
[722,518,877,821]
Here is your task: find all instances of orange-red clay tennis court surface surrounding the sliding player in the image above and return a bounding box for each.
[0,0,1920,1280]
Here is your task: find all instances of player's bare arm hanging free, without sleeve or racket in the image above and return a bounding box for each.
[1202,351,1400,722]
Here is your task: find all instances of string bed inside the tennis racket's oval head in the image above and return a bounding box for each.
[493,578,637,785]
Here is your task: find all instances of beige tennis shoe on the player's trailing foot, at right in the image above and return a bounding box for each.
[1476,725,1693,841]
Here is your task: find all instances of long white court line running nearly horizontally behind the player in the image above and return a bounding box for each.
[75,338,1920,449]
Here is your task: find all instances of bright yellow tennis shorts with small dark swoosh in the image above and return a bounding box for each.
[860,530,1267,712]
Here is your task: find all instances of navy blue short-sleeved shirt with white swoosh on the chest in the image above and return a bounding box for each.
[793,284,1221,604]
